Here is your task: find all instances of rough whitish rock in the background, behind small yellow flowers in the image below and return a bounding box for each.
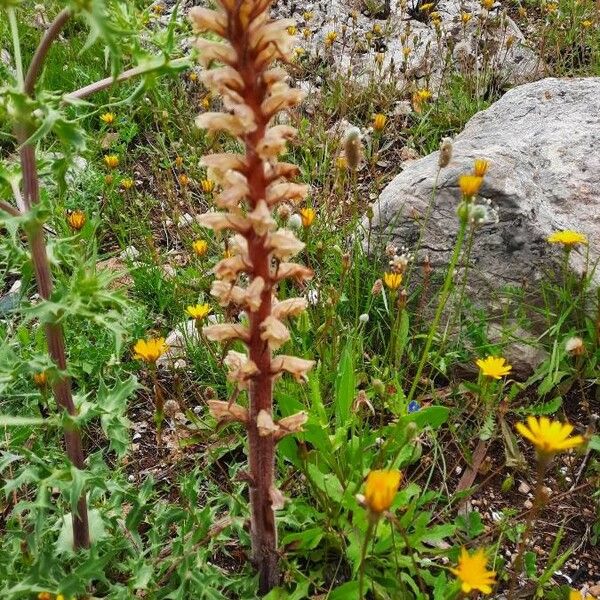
[275,0,542,94]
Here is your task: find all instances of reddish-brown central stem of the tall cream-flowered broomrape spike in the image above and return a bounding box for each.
[228,7,279,595]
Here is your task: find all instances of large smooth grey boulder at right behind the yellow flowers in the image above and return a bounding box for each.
[364,78,600,370]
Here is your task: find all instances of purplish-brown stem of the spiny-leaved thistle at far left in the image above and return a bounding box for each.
[15,9,90,550]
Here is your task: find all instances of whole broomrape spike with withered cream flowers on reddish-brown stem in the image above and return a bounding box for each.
[190,0,313,594]
